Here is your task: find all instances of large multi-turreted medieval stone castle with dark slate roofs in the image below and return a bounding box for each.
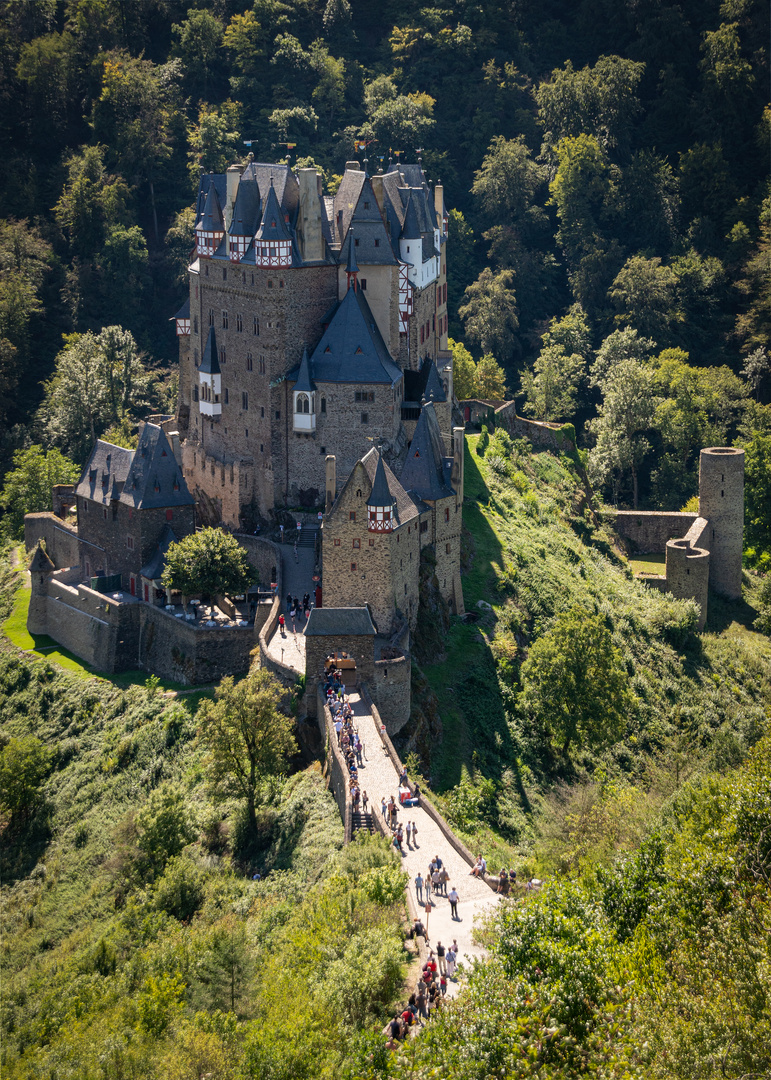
[27,161,463,723]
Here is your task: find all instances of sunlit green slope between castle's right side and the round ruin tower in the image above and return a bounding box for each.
[403,431,771,874]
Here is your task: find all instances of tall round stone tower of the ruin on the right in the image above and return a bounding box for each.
[699,446,744,599]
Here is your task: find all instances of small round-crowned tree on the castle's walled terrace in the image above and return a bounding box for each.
[163,528,256,597]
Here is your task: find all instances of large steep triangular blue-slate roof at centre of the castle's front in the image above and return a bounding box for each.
[300,288,402,386]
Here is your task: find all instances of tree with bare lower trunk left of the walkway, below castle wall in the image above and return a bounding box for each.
[199,669,297,833]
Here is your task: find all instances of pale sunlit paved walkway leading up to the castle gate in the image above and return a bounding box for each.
[350,691,498,996]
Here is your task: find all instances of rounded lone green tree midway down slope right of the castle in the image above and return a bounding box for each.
[522,607,635,754]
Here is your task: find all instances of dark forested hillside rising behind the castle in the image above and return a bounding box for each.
[0,0,771,531]
